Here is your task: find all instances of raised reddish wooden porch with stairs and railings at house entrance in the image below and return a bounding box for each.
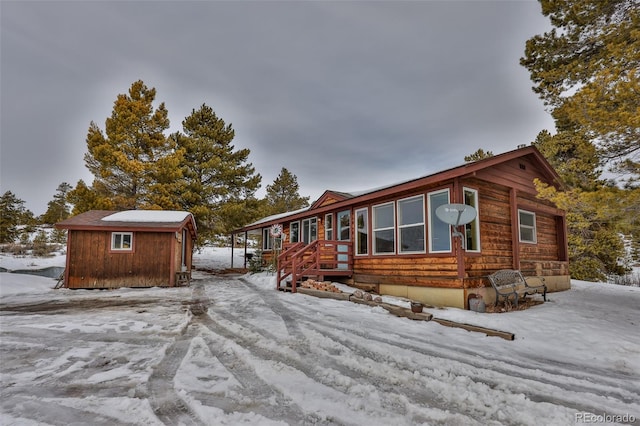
[276,240,353,293]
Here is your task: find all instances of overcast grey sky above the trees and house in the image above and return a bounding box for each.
[0,0,553,215]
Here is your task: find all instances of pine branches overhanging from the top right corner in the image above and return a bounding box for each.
[520,0,640,182]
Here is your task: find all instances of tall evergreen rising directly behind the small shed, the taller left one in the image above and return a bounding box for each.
[85,80,181,210]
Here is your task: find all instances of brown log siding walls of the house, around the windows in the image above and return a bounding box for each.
[254,158,568,296]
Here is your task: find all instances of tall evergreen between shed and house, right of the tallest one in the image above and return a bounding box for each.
[172,104,262,242]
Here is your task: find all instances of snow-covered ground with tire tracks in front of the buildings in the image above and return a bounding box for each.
[0,249,640,426]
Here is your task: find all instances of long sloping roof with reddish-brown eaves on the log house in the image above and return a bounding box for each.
[234,145,563,232]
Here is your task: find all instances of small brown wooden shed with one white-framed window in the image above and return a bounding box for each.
[56,210,196,288]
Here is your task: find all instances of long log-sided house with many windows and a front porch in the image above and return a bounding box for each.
[235,146,570,307]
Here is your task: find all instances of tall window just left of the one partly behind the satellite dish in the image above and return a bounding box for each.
[398,195,424,253]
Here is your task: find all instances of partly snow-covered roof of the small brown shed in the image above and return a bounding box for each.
[56,210,197,238]
